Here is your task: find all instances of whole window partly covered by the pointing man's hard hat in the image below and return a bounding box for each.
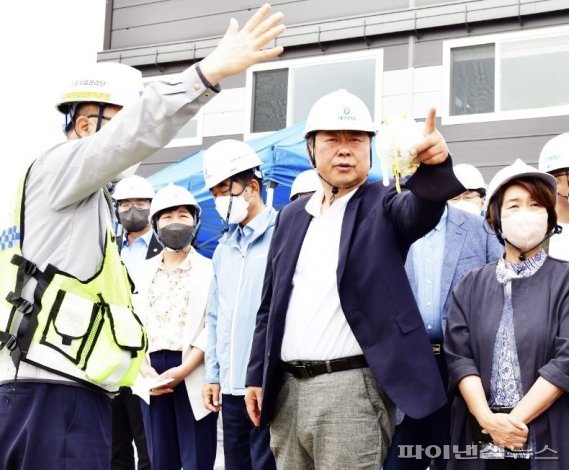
[244,50,383,139]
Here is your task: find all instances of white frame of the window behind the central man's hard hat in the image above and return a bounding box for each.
[243,49,383,140]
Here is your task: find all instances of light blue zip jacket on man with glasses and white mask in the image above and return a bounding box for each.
[205,207,277,395]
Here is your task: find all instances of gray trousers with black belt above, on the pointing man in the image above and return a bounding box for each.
[271,367,395,470]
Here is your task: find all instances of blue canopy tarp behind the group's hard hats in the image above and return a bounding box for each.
[148,122,381,257]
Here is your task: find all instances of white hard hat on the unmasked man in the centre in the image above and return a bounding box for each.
[304,89,376,136]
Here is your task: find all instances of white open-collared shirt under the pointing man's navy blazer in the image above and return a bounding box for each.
[281,189,362,361]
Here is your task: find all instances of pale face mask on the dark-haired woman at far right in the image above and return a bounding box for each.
[502,209,547,251]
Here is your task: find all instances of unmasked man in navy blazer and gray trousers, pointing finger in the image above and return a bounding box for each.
[245,90,464,468]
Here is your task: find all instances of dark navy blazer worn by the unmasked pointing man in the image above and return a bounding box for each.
[246,158,464,425]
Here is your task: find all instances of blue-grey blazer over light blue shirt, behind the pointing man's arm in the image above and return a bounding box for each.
[405,204,504,333]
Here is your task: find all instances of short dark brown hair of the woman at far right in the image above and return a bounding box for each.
[486,177,557,234]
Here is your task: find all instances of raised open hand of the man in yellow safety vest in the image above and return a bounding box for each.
[200,3,285,85]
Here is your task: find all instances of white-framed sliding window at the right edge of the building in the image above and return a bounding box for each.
[443,26,569,124]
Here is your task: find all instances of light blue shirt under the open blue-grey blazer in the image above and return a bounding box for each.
[411,209,448,342]
